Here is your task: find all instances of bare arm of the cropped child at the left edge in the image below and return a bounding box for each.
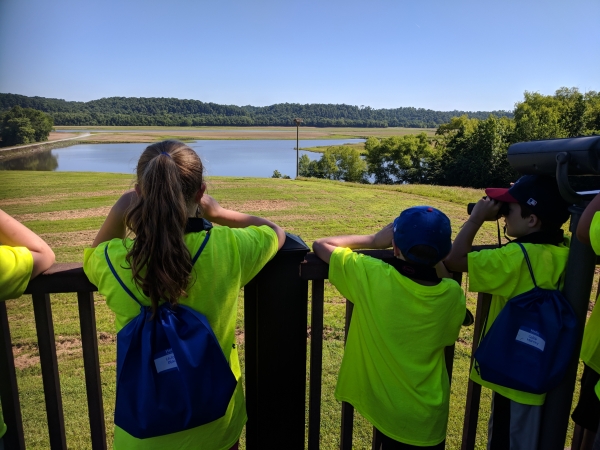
[0,210,55,278]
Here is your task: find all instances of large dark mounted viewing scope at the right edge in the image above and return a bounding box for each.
[508,136,600,205]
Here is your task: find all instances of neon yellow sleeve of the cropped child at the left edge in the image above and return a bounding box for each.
[0,245,33,300]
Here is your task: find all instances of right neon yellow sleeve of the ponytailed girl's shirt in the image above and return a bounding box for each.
[231,225,278,286]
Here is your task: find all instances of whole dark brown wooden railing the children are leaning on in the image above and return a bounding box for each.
[0,244,592,450]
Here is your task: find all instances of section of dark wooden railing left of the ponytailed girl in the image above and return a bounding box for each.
[0,264,106,450]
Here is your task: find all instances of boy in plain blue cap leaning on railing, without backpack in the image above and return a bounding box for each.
[313,206,465,450]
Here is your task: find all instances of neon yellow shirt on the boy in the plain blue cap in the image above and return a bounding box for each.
[329,248,465,446]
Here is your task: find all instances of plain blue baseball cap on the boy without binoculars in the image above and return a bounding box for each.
[394,206,452,266]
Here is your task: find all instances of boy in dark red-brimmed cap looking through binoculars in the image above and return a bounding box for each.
[445,175,569,450]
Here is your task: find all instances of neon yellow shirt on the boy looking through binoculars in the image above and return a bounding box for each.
[468,243,569,405]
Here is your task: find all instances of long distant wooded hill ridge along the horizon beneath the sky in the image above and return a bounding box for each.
[0,94,513,128]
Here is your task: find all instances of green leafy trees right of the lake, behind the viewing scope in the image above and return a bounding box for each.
[300,87,600,188]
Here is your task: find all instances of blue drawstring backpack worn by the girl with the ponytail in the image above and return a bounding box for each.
[104,231,237,439]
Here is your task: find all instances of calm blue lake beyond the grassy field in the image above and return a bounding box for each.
[0,139,365,178]
